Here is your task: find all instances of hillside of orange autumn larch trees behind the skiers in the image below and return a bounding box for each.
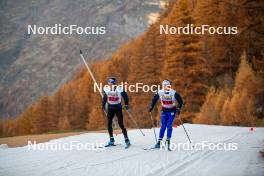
[0,0,264,135]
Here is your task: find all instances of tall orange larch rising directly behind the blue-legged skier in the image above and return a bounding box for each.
[164,1,210,120]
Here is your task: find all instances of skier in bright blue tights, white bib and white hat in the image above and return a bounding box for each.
[149,80,183,150]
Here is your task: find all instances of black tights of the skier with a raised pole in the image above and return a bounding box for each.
[107,109,128,139]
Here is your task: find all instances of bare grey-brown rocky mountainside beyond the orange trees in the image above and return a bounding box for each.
[0,0,163,118]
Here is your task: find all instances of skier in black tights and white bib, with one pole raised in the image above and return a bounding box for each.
[102,78,130,148]
